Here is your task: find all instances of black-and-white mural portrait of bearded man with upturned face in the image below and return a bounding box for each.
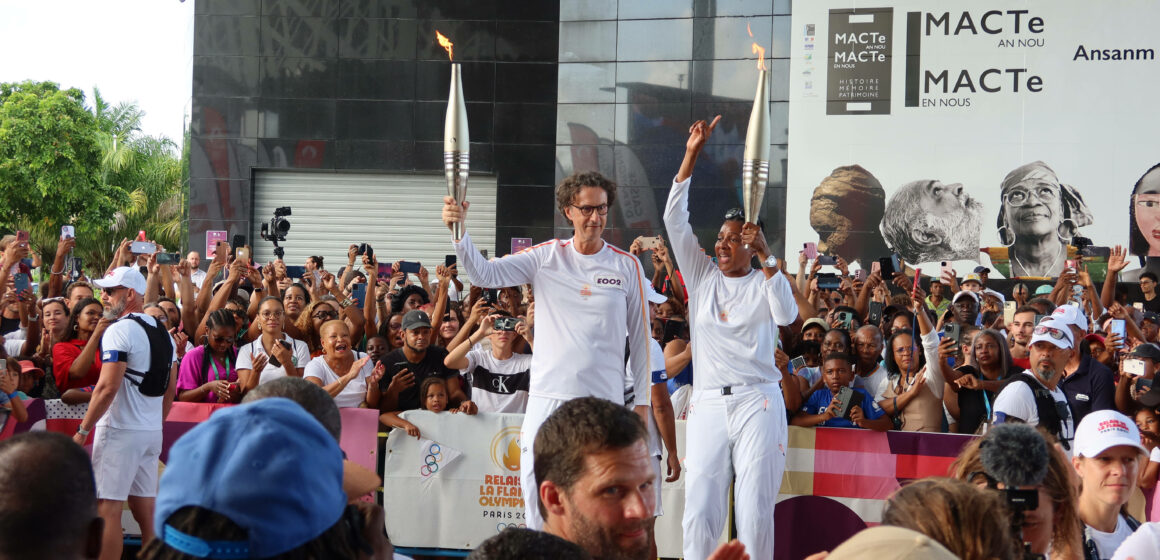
[882,180,983,264]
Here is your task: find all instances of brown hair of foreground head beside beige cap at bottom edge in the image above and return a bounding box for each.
[882,477,1022,560]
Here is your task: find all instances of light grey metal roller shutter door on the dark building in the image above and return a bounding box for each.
[249,170,495,285]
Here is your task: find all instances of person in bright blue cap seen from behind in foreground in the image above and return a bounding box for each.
[140,398,390,559]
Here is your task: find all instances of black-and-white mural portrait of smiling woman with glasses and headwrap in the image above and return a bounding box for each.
[998,161,1092,277]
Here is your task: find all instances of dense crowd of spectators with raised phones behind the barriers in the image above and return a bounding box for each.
[0,170,1160,558]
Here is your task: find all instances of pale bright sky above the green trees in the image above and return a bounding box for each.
[0,0,194,145]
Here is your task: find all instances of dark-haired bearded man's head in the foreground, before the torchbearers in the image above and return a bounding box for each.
[532,397,749,560]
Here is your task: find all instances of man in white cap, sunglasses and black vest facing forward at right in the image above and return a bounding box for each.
[992,318,1075,457]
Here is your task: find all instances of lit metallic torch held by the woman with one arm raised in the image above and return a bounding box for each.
[741,27,770,248]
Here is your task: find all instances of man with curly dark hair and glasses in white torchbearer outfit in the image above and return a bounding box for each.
[443,165,651,529]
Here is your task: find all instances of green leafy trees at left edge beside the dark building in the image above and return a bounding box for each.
[0,81,187,278]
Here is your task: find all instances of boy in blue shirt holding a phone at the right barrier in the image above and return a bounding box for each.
[790,352,893,431]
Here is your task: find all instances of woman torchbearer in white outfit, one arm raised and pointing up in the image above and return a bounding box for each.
[668,116,802,558]
